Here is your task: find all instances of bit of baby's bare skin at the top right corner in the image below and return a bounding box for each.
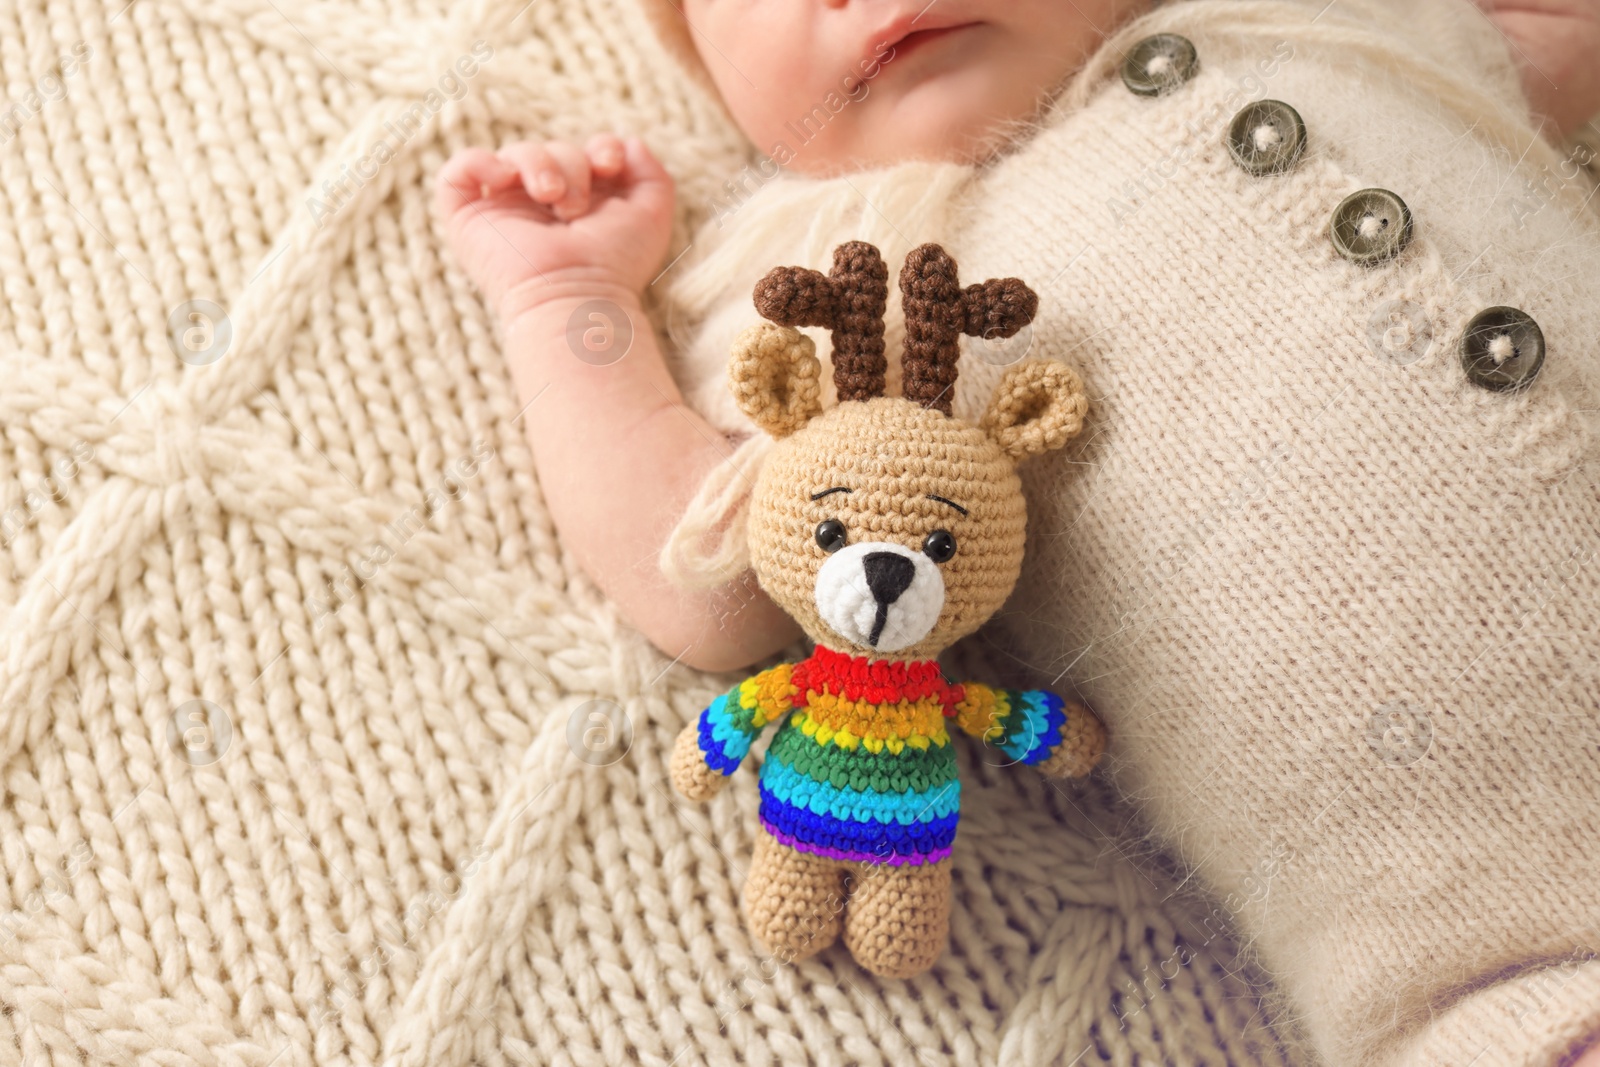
[1477,0,1600,141]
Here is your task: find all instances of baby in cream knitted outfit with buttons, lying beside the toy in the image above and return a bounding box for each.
[437,0,1600,1067]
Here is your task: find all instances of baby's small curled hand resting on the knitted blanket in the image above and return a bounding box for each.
[434,133,672,323]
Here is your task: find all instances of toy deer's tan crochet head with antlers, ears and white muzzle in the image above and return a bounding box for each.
[730,242,1088,659]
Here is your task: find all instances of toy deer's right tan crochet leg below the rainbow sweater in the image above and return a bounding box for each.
[845,859,950,977]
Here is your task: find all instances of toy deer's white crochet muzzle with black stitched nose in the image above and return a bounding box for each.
[816,541,944,651]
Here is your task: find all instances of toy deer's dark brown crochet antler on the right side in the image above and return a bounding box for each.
[901,245,1038,414]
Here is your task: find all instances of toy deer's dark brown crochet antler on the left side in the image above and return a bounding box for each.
[755,242,890,400]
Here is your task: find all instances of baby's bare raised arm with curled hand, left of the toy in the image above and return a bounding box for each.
[435,134,800,670]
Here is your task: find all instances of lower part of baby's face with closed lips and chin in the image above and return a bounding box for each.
[682,0,1152,176]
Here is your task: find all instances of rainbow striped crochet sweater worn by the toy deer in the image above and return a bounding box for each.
[699,645,1066,865]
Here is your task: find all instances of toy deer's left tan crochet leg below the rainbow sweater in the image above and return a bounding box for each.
[744,827,845,963]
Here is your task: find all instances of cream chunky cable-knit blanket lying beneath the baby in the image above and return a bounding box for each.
[0,0,1290,1067]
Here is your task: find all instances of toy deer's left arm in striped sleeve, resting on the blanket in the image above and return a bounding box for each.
[672,664,795,800]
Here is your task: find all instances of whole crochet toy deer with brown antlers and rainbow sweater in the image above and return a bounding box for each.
[672,242,1106,977]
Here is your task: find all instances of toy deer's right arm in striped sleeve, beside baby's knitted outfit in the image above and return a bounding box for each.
[955,681,1106,777]
